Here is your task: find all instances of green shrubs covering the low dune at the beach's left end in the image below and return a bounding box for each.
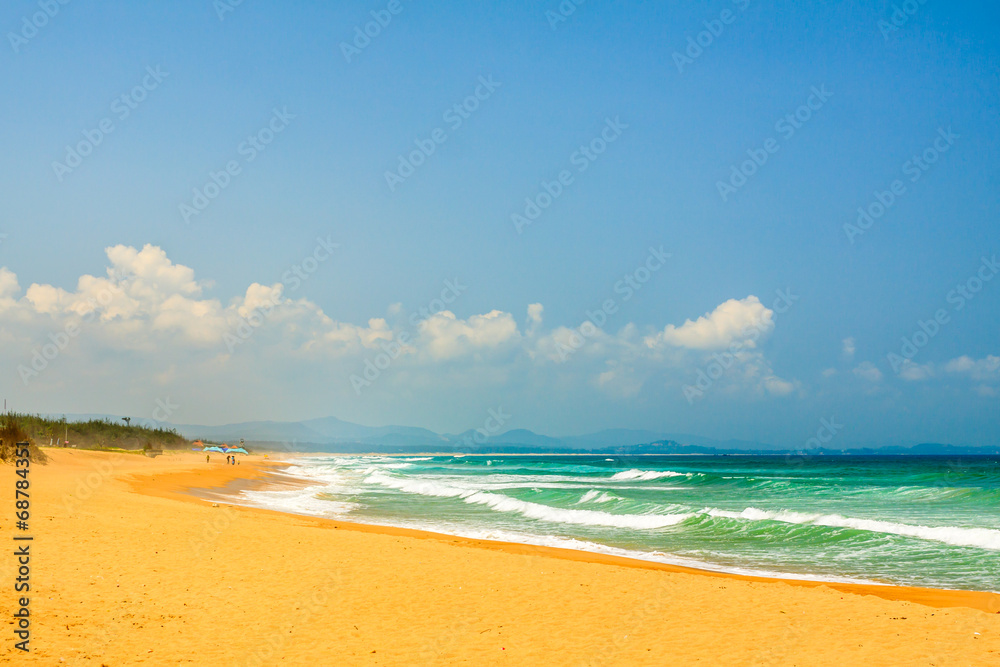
[0,413,191,450]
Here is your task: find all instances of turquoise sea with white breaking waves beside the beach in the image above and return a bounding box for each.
[244,456,1000,591]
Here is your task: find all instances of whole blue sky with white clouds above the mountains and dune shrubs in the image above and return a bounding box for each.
[0,0,1000,446]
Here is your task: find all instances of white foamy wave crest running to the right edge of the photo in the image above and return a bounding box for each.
[702,507,1000,551]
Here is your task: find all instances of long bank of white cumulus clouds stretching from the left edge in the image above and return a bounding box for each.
[0,245,798,412]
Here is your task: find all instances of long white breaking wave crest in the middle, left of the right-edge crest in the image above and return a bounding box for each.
[365,472,694,530]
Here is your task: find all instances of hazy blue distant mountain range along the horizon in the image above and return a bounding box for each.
[47,414,1000,456]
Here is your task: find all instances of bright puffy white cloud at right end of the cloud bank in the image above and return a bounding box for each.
[646,295,774,350]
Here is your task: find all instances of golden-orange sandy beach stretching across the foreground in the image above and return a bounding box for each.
[0,450,1000,666]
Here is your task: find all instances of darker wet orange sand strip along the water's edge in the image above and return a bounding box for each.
[143,454,1000,613]
